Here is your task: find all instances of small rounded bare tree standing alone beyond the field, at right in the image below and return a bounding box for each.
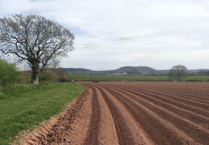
[168,65,187,81]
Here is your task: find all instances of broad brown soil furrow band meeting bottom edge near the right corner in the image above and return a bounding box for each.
[98,85,198,145]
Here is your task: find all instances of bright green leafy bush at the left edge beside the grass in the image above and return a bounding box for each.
[0,59,19,90]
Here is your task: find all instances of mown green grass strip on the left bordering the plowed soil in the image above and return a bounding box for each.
[0,83,83,145]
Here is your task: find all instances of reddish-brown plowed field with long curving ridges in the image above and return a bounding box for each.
[17,82,209,145]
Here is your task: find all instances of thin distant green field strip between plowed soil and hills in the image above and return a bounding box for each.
[66,75,209,81]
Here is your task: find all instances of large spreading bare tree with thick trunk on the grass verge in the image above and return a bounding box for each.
[0,15,74,84]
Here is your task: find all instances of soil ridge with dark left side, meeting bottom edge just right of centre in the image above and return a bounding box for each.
[93,87,153,145]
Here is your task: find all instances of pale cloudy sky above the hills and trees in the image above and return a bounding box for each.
[0,0,209,70]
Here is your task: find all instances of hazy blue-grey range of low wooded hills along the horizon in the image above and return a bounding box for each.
[64,66,209,74]
